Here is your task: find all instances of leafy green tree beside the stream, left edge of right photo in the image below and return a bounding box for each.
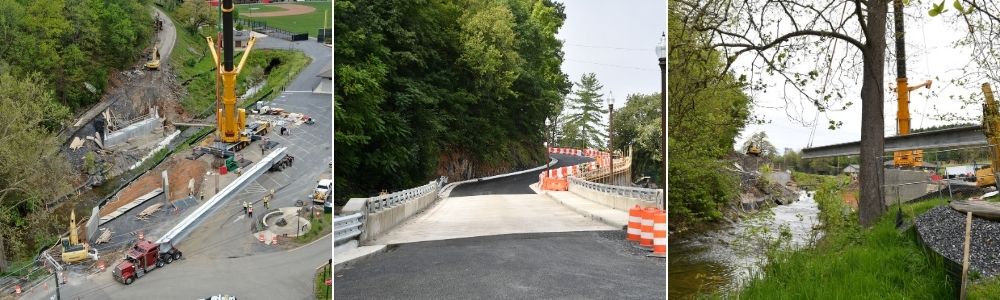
[667,5,751,227]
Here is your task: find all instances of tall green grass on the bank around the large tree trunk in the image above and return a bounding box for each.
[732,173,960,299]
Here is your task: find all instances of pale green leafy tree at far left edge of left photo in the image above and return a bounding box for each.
[0,70,70,260]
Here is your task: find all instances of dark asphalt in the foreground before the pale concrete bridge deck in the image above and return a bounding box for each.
[334,231,666,299]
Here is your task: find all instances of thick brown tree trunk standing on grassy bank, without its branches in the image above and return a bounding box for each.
[858,0,892,227]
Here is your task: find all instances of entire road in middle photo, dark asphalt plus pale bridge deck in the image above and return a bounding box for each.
[334,155,666,299]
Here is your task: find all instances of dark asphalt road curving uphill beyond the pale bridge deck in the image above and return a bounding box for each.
[449,154,594,197]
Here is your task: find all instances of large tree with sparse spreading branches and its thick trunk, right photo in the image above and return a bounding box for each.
[674,0,889,227]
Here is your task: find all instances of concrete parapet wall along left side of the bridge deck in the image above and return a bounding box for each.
[360,192,438,245]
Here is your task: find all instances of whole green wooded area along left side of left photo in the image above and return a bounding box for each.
[0,0,153,270]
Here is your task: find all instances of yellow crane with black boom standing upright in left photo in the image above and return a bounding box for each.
[205,0,257,150]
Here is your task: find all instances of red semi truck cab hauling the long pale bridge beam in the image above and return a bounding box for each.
[111,240,183,284]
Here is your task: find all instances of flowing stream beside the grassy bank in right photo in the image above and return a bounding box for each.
[667,191,822,299]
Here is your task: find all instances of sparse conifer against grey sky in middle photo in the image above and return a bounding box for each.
[564,73,608,148]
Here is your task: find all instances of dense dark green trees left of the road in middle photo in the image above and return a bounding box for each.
[334,0,571,203]
